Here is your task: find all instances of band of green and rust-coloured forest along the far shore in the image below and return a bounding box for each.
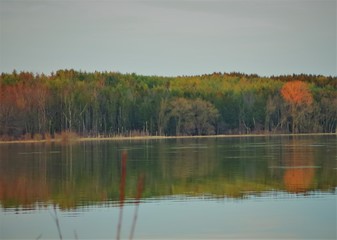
[0,70,337,140]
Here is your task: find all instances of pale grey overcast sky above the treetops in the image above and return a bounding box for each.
[0,0,337,76]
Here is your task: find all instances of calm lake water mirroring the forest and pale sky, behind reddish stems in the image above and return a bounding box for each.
[0,136,337,239]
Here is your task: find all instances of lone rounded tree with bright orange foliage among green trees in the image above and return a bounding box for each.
[281,81,313,133]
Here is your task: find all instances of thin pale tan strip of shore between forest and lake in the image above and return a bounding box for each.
[0,133,337,144]
